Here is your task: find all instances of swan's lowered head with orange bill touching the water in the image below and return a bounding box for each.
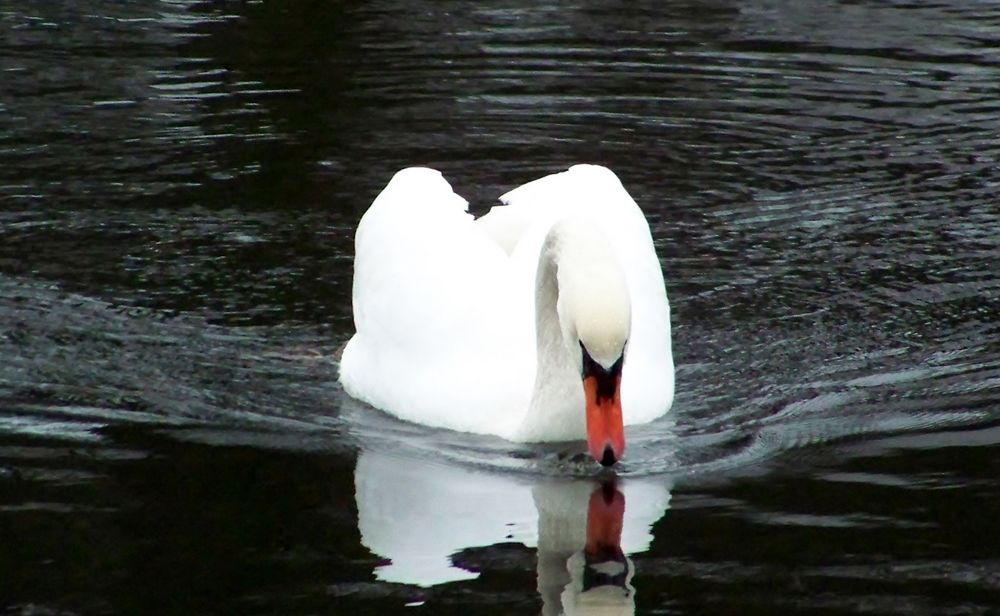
[557,222,632,466]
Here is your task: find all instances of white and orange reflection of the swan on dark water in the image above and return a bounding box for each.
[355,451,670,614]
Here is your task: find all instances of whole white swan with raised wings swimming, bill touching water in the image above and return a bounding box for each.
[339,165,674,466]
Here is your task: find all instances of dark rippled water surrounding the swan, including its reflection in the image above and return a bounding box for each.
[0,0,1000,614]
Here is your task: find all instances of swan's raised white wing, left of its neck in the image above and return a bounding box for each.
[340,168,533,433]
